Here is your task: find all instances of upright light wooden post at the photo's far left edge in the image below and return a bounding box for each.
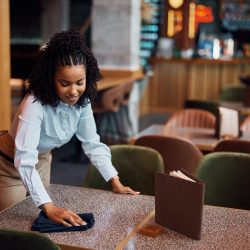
[0,0,11,130]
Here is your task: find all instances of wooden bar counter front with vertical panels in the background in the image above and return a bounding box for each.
[140,58,250,114]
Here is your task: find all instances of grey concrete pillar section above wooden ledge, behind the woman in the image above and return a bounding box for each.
[91,0,141,71]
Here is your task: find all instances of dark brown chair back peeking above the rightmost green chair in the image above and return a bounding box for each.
[214,140,250,154]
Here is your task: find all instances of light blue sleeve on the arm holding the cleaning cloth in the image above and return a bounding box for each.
[14,99,51,206]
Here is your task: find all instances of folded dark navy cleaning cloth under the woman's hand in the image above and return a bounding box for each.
[31,211,95,233]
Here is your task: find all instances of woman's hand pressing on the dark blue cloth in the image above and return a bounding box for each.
[41,202,87,227]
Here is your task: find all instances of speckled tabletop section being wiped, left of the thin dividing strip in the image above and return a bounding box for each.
[0,185,154,250]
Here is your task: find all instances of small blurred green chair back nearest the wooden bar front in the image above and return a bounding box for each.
[219,84,246,102]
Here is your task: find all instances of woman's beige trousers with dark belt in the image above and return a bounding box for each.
[0,133,52,211]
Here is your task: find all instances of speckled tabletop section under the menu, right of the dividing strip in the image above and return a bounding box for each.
[124,206,250,250]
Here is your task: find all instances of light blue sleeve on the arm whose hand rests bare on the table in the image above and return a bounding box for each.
[76,104,118,181]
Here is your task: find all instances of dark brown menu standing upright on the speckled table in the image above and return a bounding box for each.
[155,169,204,240]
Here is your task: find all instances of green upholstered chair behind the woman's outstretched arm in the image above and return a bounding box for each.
[84,145,164,195]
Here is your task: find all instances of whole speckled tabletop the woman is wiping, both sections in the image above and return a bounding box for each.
[0,185,250,250]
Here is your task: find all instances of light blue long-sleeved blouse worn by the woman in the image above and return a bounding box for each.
[9,95,117,206]
